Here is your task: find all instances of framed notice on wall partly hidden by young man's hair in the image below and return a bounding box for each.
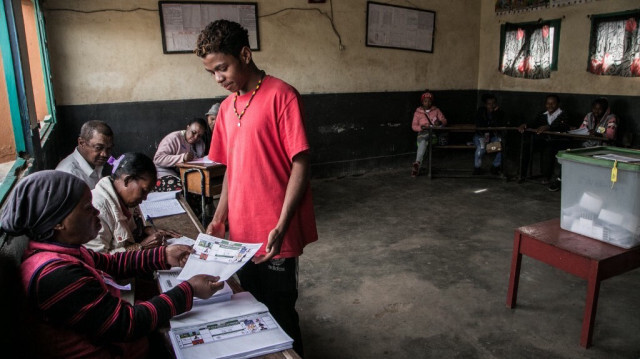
[158,1,260,54]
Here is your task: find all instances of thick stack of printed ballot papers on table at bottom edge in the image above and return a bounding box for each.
[169,292,293,359]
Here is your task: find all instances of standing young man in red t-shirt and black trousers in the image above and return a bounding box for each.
[196,20,318,355]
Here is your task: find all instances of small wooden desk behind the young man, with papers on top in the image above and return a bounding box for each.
[176,163,227,225]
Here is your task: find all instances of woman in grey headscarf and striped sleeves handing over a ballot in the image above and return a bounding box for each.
[0,171,223,358]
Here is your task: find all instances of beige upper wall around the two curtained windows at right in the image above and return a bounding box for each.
[478,0,640,96]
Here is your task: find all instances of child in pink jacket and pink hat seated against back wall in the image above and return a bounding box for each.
[411,91,447,177]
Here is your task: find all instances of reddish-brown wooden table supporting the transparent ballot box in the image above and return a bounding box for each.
[507,219,640,348]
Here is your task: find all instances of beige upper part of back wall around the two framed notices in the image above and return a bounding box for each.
[45,0,481,105]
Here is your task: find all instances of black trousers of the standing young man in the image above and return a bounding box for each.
[238,257,304,357]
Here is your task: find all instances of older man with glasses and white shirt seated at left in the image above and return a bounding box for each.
[56,121,113,189]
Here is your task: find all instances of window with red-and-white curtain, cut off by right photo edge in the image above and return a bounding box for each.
[587,11,640,77]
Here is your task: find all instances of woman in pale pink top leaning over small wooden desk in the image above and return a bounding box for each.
[153,118,208,192]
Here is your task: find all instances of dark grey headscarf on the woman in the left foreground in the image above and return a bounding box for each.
[0,170,89,242]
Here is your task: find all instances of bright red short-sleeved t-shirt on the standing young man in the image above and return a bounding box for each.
[209,76,318,258]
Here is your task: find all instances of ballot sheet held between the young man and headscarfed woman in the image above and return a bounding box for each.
[178,233,262,280]
